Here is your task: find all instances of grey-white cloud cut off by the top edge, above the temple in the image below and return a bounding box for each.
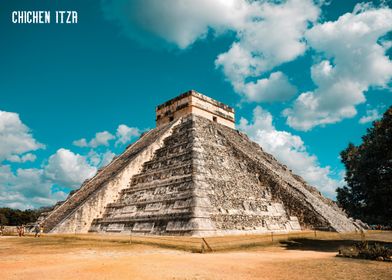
[102,0,256,49]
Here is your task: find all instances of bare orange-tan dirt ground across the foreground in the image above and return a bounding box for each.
[0,236,392,280]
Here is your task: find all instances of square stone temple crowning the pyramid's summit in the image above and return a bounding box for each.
[156,90,235,128]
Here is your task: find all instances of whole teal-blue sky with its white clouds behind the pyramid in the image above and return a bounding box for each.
[0,0,392,208]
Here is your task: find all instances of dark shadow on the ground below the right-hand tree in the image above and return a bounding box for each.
[280,238,392,252]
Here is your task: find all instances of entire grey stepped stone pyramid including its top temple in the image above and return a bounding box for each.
[43,91,361,236]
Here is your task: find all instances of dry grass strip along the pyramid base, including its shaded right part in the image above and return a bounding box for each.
[4,231,392,255]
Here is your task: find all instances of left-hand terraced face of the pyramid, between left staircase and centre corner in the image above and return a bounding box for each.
[91,117,211,235]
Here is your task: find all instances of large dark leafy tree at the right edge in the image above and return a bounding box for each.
[337,106,392,225]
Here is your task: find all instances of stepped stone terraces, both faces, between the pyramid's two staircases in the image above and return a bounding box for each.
[95,116,300,235]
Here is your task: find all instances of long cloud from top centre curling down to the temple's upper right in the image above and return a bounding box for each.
[102,0,320,102]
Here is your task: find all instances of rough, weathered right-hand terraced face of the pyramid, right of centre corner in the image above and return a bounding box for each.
[194,117,300,234]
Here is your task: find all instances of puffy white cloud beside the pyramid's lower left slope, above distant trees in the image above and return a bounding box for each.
[44,148,97,188]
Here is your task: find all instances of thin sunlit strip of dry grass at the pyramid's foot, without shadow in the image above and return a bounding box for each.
[16,231,392,253]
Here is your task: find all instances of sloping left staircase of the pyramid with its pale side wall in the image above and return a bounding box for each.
[44,121,178,233]
